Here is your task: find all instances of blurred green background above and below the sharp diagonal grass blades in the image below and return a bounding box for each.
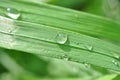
[0,0,120,80]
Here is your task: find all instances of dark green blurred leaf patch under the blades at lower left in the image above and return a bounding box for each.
[5,50,49,77]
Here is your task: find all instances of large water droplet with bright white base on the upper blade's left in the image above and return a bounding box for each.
[7,8,21,19]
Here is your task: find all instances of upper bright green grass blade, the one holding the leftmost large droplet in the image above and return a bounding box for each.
[0,0,120,41]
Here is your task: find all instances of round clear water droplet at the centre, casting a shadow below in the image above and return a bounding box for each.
[56,33,68,44]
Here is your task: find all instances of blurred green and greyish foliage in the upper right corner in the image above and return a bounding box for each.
[84,0,120,21]
